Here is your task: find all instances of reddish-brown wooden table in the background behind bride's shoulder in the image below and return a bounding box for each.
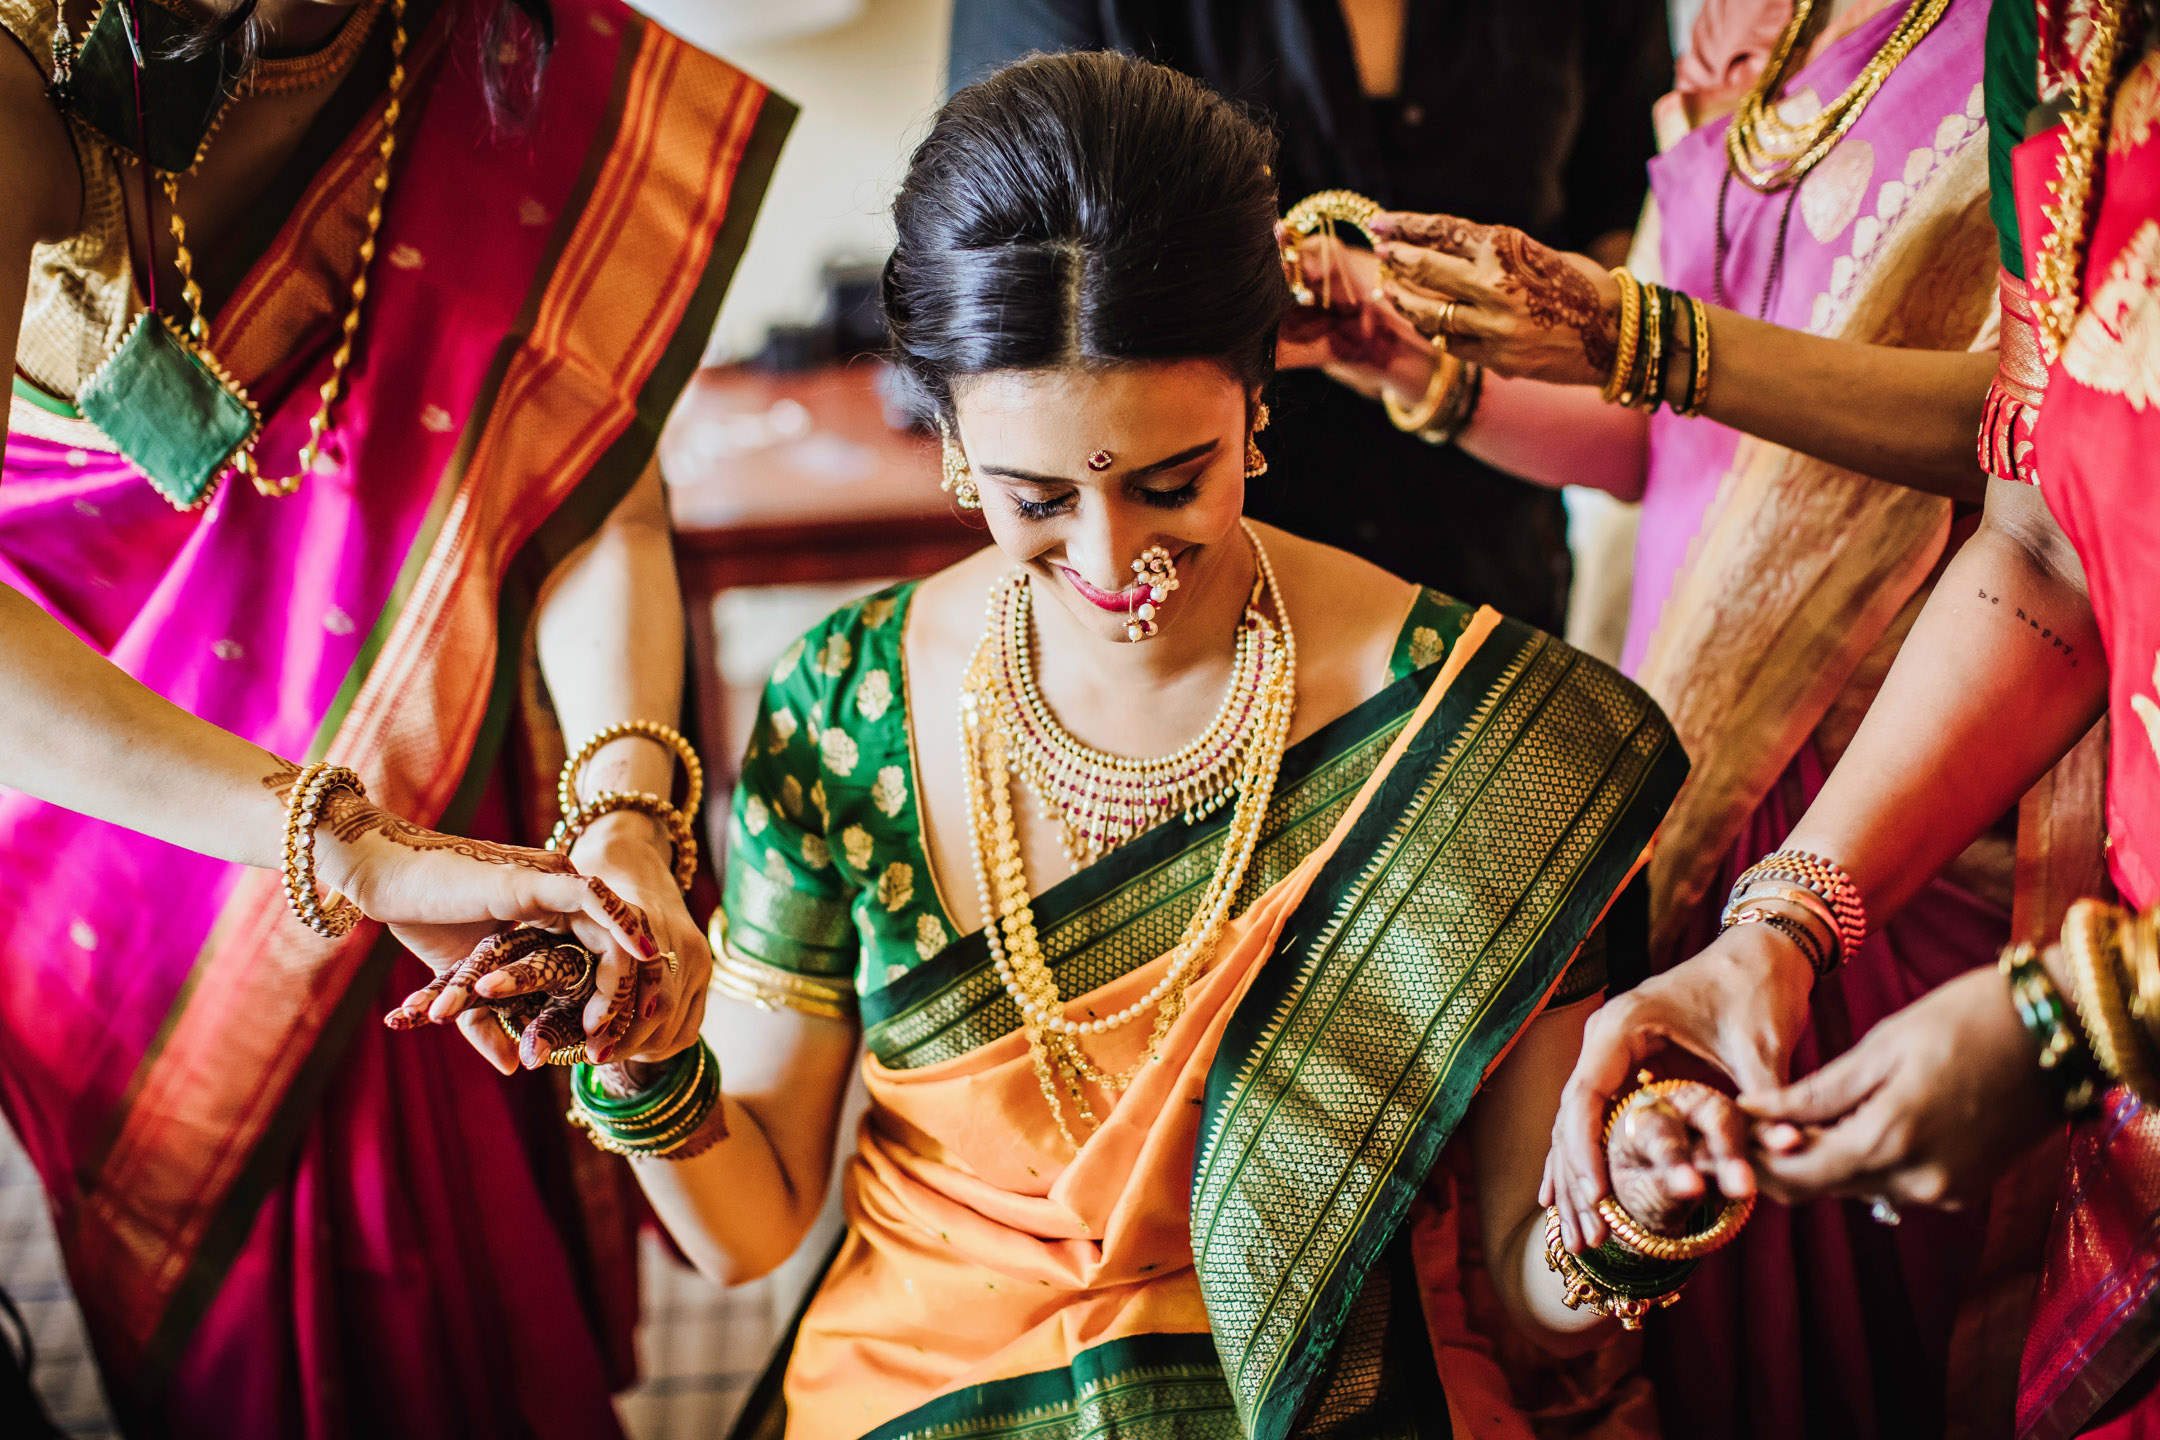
[659,361,989,803]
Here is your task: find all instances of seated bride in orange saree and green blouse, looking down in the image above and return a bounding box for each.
[447,54,1702,1438]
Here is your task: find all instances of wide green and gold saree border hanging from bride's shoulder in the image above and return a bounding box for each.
[1192,622,1687,1440]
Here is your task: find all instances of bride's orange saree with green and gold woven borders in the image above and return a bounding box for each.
[745,611,1687,1440]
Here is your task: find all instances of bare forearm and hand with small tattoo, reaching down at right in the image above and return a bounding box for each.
[1553,479,2108,1244]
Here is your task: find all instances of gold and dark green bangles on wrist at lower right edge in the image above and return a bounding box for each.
[2000,900,2160,1118]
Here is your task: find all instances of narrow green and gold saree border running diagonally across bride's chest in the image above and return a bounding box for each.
[862,651,1468,1071]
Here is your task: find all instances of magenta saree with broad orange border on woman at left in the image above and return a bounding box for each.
[0,0,793,1440]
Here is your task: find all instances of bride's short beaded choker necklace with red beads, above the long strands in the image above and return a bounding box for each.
[985,570,1277,870]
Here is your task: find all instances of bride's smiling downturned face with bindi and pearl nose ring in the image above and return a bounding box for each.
[953,361,1251,641]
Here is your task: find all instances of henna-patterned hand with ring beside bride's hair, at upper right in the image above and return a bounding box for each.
[1374,212,1620,384]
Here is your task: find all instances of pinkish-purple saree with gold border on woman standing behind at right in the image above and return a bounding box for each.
[1622,0,2009,1440]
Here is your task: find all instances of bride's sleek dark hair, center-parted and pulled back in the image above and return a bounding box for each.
[883,52,1290,417]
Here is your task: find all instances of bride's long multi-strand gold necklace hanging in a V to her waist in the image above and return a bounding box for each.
[961,525,1298,1149]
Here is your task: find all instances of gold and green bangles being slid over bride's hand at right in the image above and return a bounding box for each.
[1544,1071,1754,1330]
